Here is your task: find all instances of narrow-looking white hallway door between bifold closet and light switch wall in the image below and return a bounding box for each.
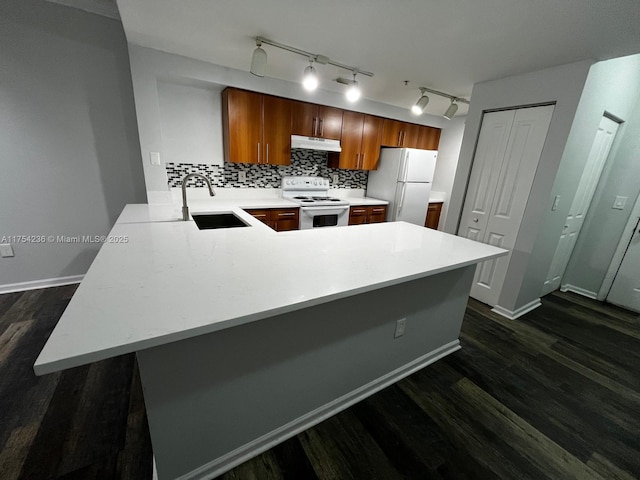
[542,117,618,295]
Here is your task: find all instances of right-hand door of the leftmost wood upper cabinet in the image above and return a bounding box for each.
[260,95,291,165]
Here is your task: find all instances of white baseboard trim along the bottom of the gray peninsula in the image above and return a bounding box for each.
[177,340,461,480]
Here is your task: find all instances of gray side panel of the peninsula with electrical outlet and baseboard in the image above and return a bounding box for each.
[137,265,476,480]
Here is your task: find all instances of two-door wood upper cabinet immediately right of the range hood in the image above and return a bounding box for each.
[329,111,383,170]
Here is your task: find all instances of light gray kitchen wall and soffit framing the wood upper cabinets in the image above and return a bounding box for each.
[129,44,462,210]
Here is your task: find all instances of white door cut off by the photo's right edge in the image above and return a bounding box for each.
[607,218,640,312]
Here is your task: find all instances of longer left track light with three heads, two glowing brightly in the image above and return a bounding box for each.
[250,37,373,98]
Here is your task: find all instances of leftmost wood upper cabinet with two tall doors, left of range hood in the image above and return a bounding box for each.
[222,88,292,165]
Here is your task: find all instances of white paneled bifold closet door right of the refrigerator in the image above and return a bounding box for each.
[459,105,554,306]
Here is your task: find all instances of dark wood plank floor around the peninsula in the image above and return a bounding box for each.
[0,286,640,480]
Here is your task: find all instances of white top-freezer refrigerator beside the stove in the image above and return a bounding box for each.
[367,148,438,227]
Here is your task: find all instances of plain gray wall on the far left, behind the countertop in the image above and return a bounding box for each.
[0,0,145,291]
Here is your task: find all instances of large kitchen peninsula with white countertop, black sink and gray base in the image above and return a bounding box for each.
[34,199,507,480]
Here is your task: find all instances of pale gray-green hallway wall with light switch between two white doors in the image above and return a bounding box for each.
[562,55,640,294]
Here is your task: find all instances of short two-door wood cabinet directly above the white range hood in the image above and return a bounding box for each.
[291,101,342,140]
